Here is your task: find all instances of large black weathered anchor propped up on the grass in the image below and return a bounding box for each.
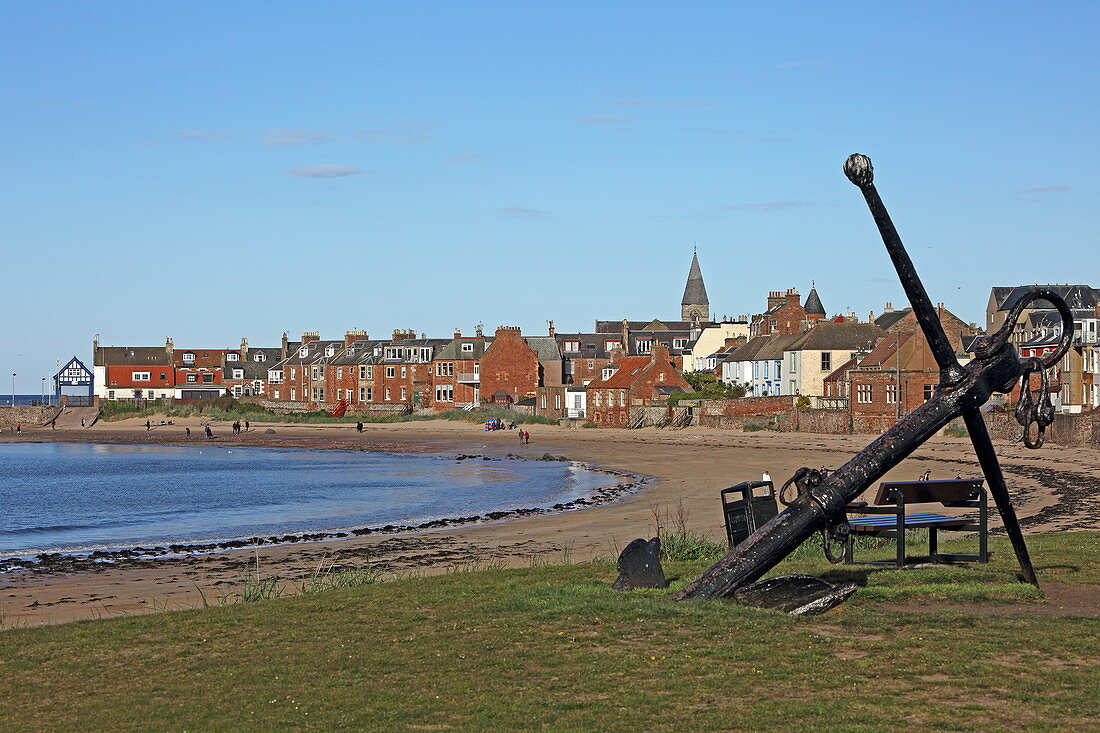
[675,154,1074,601]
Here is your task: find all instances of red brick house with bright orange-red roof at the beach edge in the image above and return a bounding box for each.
[586,346,691,427]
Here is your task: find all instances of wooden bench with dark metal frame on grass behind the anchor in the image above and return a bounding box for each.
[844,479,989,568]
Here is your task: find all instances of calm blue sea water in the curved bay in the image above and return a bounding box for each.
[0,444,607,557]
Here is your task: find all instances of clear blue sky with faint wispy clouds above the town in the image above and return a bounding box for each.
[0,0,1100,392]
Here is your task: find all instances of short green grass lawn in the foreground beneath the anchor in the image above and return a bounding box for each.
[0,533,1100,731]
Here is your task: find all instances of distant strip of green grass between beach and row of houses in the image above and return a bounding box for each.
[99,397,558,425]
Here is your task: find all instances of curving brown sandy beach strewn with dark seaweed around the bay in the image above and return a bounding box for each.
[0,418,1100,625]
